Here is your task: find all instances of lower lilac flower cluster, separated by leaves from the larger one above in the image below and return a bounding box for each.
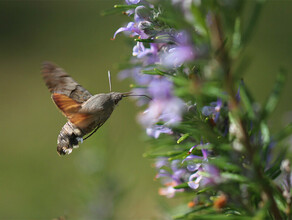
[155,141,223,198]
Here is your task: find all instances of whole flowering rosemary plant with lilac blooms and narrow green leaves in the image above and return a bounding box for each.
[113,0,292,219]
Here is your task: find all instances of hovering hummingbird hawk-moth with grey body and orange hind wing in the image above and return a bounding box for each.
[42,62,139,155]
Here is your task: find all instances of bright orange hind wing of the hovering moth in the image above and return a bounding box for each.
[52,93,94,130]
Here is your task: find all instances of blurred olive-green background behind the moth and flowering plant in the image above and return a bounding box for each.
[0,0,292,219]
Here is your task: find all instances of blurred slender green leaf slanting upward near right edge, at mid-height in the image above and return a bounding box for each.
[261,69,286,120]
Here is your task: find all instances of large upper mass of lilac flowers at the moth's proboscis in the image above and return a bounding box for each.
[114,1,195,138]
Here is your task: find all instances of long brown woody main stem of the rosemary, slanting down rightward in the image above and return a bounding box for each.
[210,13,282,220]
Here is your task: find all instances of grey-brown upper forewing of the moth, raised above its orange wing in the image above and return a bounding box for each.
[42,62,92,103]
